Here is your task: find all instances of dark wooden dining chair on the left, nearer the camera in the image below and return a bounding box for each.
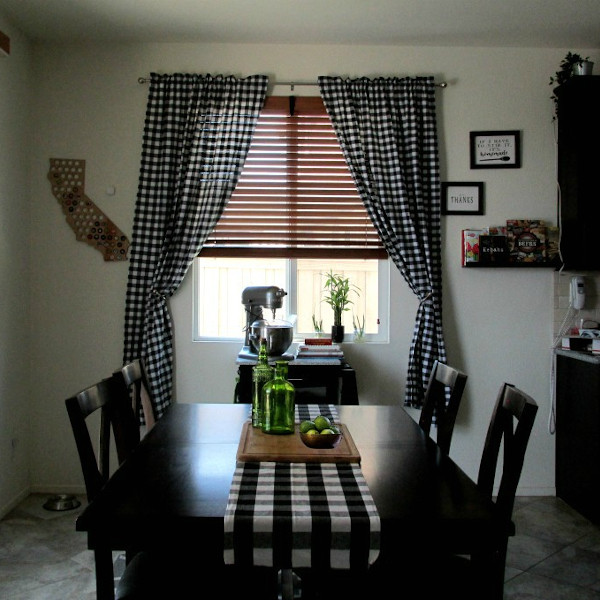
[65,375,162,600]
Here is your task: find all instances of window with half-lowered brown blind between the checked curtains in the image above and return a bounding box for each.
[194,97,389,341]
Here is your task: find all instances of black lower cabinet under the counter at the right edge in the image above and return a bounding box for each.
[556,351,600,523]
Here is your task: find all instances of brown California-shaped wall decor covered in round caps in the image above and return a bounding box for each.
[48,158,129,261]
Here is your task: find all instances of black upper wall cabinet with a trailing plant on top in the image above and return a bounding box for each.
[555,75,600,271]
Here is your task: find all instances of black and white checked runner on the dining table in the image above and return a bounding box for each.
[224,404,380,569]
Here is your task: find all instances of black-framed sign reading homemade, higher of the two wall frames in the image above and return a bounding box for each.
[470,131,521,169]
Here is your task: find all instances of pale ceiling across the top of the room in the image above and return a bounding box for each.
[0,0,600,52]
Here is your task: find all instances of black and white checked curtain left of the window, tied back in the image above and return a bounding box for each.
[123,73,268,417]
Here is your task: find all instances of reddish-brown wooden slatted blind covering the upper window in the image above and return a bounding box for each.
[200,96,387,258]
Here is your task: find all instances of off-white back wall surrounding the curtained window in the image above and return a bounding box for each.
[0,36,600,506]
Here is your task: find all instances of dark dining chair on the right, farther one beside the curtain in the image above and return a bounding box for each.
[419,360,467,454]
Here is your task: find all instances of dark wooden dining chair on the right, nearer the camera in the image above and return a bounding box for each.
[366,383,538,600]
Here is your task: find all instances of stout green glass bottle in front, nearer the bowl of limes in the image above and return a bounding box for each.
[261,360,296,434]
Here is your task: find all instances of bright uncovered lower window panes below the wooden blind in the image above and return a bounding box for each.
[194,257,389,341]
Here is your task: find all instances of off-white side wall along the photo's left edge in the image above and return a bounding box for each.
[0,16,37,515]
